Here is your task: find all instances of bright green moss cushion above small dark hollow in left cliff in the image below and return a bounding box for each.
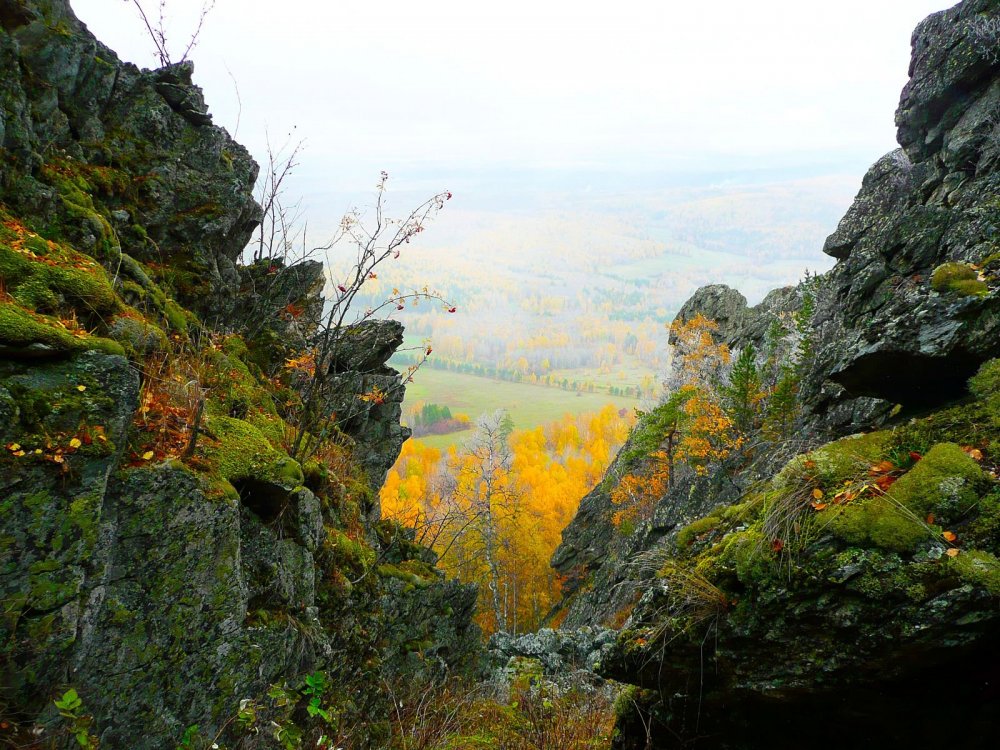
[202,416,304,487]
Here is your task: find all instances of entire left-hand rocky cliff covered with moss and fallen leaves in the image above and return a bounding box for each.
[0,0,478,748]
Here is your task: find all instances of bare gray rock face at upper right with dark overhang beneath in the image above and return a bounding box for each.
[803,0,1000,427]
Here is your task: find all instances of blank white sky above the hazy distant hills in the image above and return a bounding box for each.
[72,0,947,197]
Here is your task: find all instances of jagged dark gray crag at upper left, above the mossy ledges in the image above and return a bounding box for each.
[0,0,261,320]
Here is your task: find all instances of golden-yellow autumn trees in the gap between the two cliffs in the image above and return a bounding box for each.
[381,405,632,633]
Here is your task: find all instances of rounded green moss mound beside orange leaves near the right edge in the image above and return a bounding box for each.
[890,443,988,522]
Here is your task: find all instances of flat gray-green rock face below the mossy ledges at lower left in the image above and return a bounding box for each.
[0,352,333,749]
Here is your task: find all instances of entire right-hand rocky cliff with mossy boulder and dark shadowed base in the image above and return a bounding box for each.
[553,0,1000,748]
